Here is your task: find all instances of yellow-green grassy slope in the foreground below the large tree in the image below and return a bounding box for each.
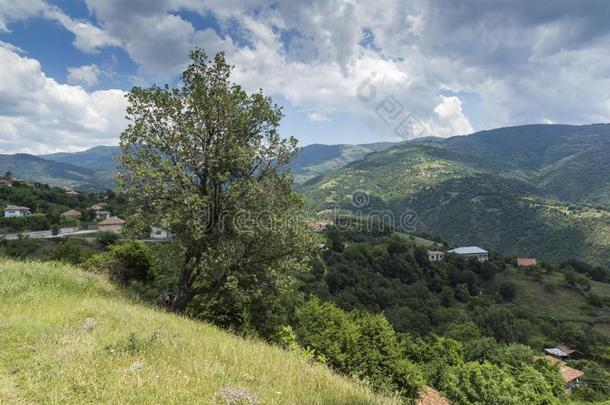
[0,261,390,404]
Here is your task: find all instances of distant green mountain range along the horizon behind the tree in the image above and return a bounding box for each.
[0,124,610,264]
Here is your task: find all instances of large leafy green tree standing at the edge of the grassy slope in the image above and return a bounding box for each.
[117,49,316,312]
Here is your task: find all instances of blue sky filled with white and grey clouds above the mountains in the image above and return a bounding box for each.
[0,0,610,154]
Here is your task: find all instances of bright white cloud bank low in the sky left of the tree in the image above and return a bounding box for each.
[0,47,126,153]
